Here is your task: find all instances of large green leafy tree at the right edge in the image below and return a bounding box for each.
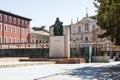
[94,0,120,45]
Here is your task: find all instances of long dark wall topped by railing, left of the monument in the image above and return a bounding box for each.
[0,43,49,58]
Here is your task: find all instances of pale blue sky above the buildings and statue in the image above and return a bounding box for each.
[0,0,96,29]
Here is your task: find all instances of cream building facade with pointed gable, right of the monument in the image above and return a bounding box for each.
[71,17,104,47]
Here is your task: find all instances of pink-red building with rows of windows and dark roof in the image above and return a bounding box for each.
[0,10,31,43]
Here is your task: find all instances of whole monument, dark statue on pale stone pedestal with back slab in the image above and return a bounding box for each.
[49,18,70,58]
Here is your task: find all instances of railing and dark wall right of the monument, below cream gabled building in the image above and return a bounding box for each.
[70,42,120,62]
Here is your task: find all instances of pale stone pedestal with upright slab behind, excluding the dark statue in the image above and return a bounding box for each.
[49,26,70,58]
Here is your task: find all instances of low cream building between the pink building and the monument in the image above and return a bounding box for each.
[30,30,49,48]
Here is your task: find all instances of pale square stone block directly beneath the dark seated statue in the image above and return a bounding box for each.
[49,36,65,57]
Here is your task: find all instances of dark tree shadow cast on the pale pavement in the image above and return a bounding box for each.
[64,64,120,80]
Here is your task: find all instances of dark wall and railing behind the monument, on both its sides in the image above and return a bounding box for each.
[0,43,120,58]
